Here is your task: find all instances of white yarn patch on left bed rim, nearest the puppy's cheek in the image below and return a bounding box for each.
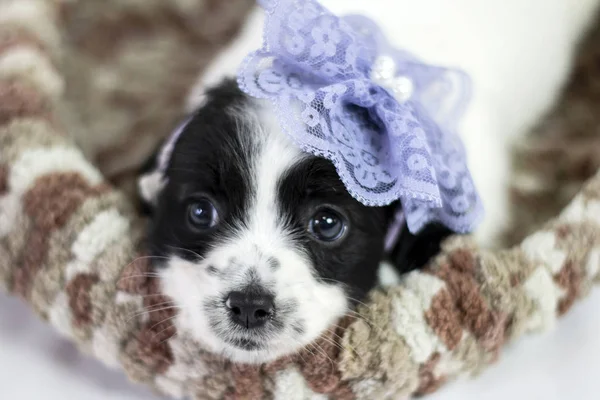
[65,209,130,280]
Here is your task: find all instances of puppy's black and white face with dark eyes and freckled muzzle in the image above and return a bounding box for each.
[144,82,389,363]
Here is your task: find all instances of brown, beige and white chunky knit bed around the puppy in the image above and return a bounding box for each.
[0,0,600,399]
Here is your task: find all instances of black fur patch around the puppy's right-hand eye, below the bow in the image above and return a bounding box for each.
[279,157,393,299]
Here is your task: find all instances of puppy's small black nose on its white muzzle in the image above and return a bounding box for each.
[225,291,274,329]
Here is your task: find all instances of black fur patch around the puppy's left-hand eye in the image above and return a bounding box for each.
[149,81,253,259]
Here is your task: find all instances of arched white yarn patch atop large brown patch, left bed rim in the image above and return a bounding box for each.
[9,146,103,195]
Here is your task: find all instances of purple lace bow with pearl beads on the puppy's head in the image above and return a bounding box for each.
[238,0,483,233]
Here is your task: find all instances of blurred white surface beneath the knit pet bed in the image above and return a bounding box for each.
[0,290,600,400]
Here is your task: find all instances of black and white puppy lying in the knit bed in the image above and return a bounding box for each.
[140,0,596,363]
